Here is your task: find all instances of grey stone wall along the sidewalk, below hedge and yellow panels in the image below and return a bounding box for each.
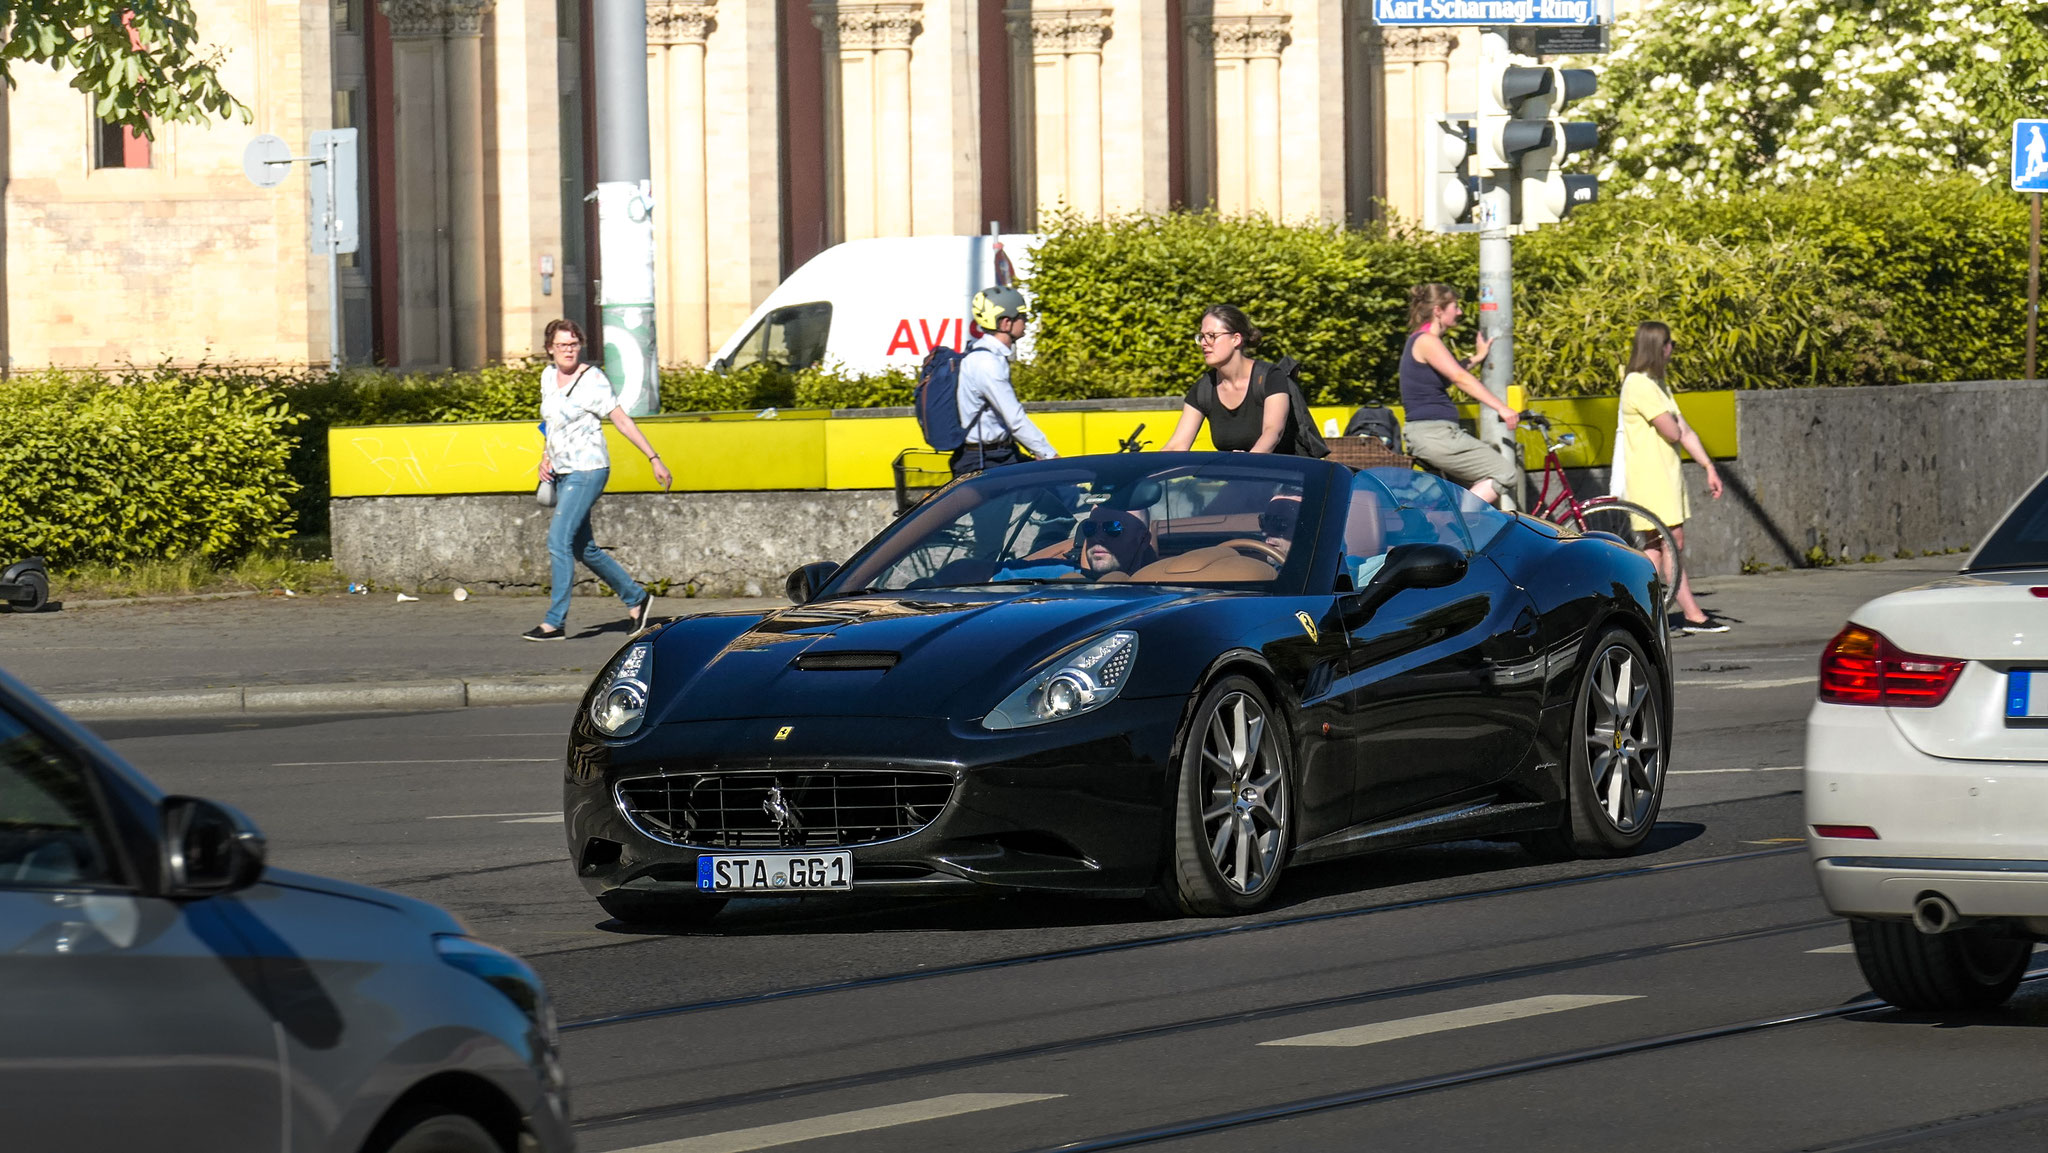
[334,381,2048,596]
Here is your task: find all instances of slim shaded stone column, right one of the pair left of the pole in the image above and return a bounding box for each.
[442,0,496,369]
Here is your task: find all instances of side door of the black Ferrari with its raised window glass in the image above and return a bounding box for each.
[1335,469,1542,821]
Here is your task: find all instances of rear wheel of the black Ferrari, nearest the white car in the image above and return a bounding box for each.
[1524,629,1669,858]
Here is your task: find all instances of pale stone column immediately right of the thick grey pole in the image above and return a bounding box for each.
[647,0,717,365]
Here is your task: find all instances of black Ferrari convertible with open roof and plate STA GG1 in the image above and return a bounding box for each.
[563,453,1671,924]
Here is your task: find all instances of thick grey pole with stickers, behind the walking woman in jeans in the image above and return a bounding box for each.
[592,0,662,416]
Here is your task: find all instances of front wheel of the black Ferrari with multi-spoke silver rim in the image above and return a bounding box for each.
[1159,676,1292,917]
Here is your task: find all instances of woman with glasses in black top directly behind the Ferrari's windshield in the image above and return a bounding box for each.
[1165,305,1300,457]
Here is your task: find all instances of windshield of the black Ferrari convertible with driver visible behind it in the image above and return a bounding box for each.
[821,453,1323,596]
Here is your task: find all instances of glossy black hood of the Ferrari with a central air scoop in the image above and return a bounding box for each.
[653,586,1227,723]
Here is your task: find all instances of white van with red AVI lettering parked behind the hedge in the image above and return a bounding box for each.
[711,233,1038,373]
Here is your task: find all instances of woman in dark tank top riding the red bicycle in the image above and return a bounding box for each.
[1401,285,1522,504]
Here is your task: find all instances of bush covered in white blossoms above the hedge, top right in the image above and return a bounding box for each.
[1573,0,2048,195]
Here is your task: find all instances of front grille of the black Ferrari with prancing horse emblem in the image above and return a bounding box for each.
[618,768,952,850]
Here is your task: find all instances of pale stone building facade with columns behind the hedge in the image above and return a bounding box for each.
[0,0,1630,371]
